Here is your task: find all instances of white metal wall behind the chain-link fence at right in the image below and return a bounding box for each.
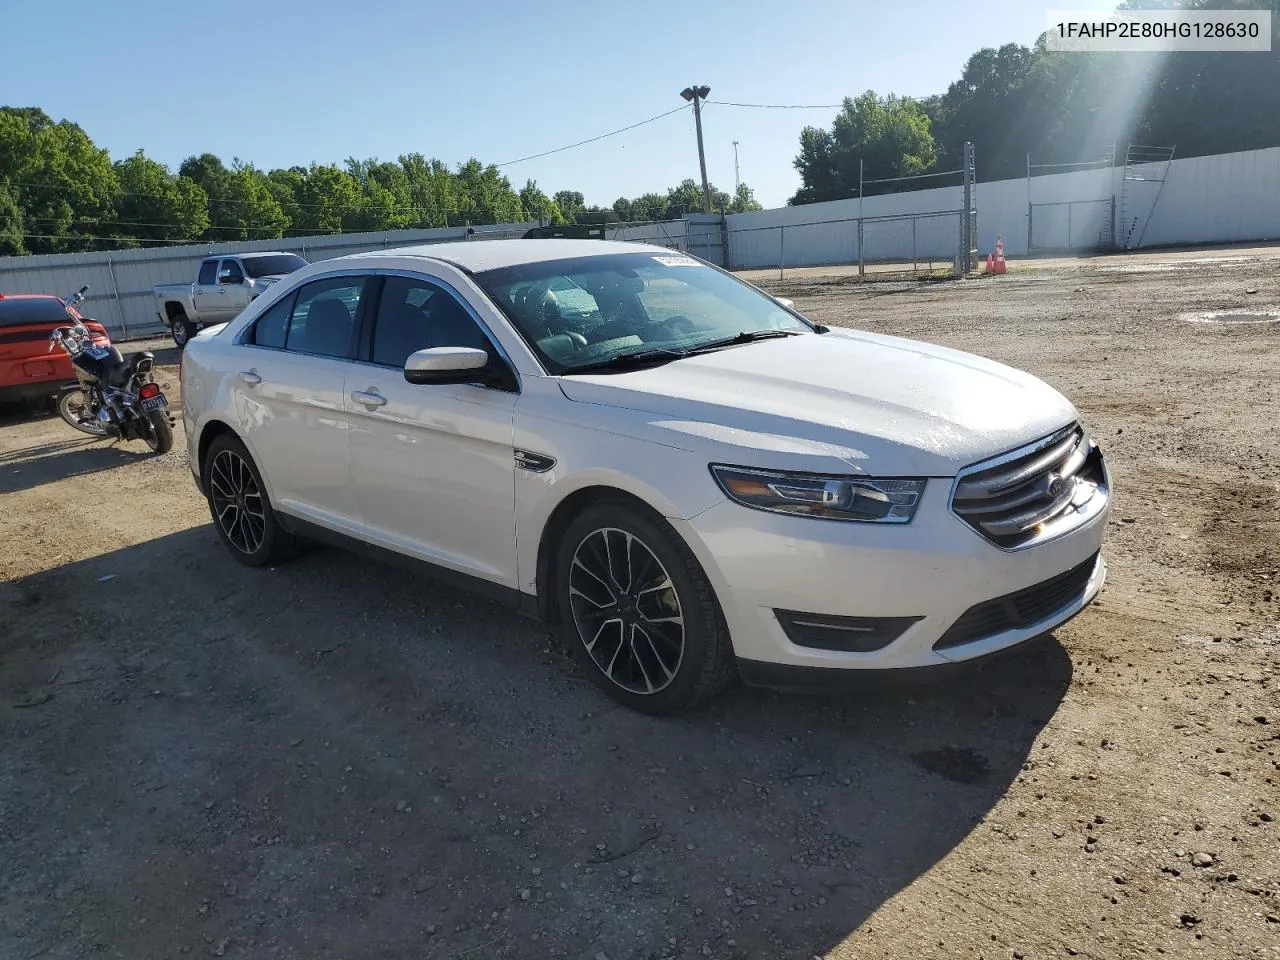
[727,147,1280,269]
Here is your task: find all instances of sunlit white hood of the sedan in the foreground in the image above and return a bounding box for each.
[559,330,1076,476]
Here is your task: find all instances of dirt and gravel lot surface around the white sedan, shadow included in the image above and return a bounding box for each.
[0,250,1280,960]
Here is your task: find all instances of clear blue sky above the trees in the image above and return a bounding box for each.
[0,0,1114,206]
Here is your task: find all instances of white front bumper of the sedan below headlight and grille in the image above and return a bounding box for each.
[672,480,1110,686]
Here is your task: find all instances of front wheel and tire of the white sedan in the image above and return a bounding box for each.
[556,502,736,717]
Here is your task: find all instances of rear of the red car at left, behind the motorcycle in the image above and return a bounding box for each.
[0,293,110,402]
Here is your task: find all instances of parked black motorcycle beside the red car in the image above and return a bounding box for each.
[49,285,174,453]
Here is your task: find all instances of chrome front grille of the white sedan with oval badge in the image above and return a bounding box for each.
[951,424,1107,549]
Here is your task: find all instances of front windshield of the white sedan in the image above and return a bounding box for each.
[475,252,813,374]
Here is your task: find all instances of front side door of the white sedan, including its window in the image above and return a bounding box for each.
[347,275,518,588]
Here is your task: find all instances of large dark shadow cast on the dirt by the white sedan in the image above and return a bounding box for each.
[0,525,1071,960]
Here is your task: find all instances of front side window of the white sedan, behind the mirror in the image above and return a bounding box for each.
[372,276,492,366]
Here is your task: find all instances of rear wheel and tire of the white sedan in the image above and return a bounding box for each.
[200,434,298,567]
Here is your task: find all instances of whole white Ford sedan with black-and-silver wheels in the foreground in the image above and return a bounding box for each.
[182,239,1110,714]
